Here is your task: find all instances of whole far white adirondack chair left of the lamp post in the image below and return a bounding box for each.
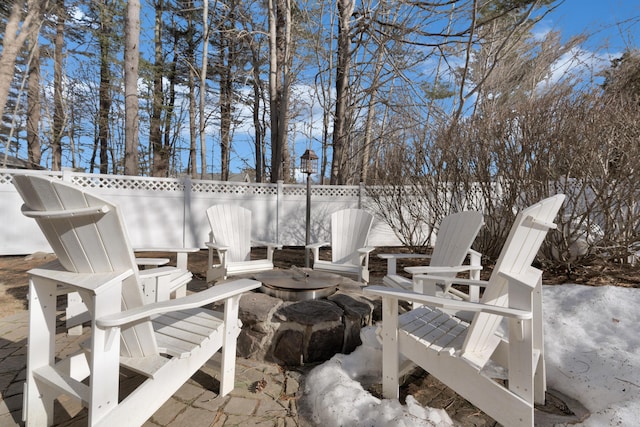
[206,205,282,282]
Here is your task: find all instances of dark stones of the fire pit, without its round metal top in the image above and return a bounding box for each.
[238,276,381,366]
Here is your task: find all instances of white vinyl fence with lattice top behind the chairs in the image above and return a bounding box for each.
[0,169,401,255]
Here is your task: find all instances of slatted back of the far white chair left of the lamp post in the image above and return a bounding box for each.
[207,204,251,262]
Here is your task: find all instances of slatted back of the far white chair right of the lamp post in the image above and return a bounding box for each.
[331,209,373,265]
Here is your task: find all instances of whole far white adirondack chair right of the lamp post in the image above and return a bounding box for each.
[306,209,375,283]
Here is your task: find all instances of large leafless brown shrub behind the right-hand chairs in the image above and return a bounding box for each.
[370,62,640,269]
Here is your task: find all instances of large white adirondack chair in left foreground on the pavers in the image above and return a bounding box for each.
[13,175,260,427]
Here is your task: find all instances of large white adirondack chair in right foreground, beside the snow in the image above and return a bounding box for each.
[365,195,564,426]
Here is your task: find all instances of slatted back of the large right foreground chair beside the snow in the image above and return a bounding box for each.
[463,194,565,366]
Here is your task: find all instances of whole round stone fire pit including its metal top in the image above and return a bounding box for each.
[230,267,382,366]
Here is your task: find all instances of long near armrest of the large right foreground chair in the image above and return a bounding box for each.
[364,286,533,320]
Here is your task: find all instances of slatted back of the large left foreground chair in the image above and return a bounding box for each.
[13,175,158,357]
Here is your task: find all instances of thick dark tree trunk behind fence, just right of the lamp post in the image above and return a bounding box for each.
[330,0,355,185]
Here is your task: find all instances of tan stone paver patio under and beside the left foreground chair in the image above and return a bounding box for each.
[0,311,311,427]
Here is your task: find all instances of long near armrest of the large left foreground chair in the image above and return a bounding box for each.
[96,279,262,328]
